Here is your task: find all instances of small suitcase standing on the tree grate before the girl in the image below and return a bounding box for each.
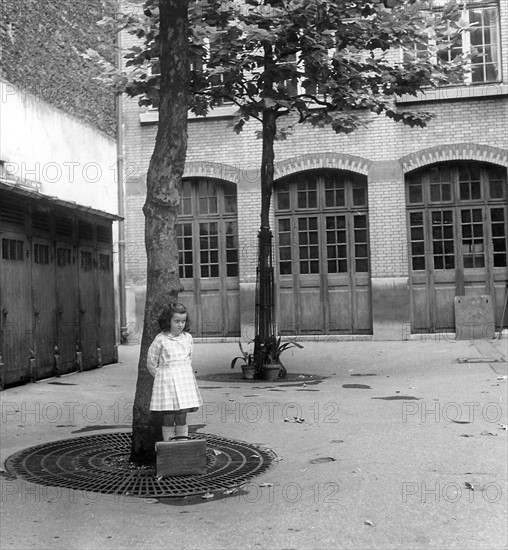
[155,436,206,477]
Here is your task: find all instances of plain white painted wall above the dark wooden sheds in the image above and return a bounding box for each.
[0,80,118,218]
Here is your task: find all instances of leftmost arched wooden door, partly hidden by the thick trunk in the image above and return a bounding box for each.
[177,178,240,336]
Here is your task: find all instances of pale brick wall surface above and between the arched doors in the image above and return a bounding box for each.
[120,2,508,336]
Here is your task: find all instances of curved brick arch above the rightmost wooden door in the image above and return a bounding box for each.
[399,143,508,173]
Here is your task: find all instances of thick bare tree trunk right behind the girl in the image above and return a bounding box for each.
[131,0,189,464]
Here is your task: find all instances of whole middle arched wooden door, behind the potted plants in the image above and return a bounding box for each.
[275,170,372,334]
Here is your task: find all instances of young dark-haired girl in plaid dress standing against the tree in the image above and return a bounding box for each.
[146,304,203,441]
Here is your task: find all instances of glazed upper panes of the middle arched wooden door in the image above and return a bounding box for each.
[275,171,369,275]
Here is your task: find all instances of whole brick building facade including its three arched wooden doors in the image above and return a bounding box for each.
[120,1,508,339]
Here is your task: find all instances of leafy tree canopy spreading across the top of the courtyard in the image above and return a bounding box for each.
[116,0,466,133]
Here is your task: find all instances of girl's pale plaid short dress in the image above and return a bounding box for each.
[146,332,203,411]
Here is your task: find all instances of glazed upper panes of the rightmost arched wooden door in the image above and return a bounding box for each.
[407,163,506,271]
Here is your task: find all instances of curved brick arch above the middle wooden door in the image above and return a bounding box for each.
[274,152,372,180]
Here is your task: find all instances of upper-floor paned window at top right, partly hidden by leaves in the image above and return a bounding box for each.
[406,0,501,84]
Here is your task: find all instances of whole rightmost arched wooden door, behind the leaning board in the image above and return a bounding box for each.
[406,163,508,332]
